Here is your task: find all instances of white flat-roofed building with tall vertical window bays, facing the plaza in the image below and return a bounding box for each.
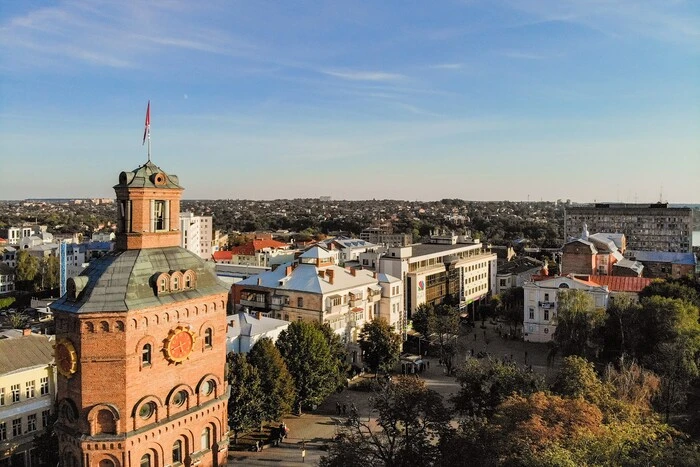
[379,235,496,319]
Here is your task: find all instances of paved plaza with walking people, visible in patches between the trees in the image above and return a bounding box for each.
[229,323,559,466]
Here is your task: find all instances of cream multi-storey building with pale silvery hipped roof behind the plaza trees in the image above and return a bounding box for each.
[232,246,404,362]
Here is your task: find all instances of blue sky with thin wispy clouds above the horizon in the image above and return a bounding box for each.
[0,0,700,203]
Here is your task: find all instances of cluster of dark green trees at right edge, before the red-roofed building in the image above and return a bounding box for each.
[554,281,700,422]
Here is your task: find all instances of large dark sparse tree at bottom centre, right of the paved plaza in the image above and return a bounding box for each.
[320,377,450,467]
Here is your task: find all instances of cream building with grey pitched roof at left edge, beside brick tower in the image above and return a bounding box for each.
[0,329,56,467]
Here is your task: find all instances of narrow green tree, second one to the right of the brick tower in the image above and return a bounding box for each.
[248,338,296,421]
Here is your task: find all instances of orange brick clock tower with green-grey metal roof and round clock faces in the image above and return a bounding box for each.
[51,160,228,467]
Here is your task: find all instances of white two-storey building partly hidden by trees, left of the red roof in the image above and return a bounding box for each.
[523,276,610,342]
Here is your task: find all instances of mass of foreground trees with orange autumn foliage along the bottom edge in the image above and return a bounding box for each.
[321,356,700,467]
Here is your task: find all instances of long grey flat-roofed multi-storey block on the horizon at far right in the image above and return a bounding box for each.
[564,203,693,252]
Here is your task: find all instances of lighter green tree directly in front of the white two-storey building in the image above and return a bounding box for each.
[553,290,606,355]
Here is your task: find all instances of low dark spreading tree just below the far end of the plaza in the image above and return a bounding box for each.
[452,359,545,416]
